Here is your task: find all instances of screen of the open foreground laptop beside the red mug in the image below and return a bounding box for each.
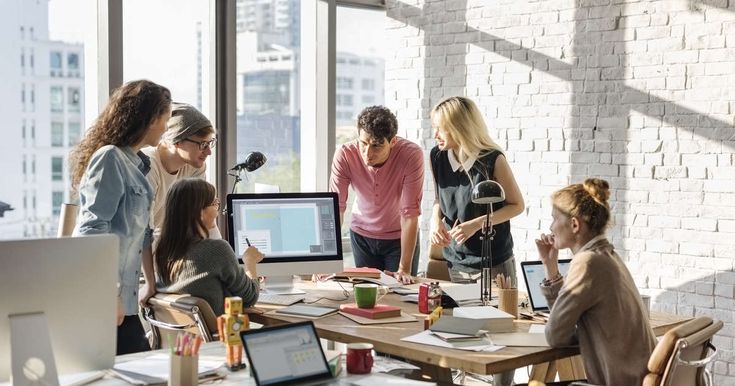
[242,325,329,385]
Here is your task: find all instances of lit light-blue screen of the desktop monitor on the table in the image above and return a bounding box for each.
[232,197,338,259]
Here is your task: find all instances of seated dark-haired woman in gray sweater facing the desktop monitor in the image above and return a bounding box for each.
[154,178,263,315]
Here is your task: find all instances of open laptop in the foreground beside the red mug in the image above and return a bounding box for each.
[240,321,349,386]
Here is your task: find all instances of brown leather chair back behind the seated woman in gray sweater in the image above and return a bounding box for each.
[142,293,218,349]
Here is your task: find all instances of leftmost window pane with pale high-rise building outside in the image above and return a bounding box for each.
[0,0,89,239]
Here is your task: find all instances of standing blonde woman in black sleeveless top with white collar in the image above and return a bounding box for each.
[430,97,524,386]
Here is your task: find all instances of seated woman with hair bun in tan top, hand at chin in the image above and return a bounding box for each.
[536,178,656,385]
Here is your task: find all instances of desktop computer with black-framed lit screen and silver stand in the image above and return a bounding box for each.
[227,192,343,294]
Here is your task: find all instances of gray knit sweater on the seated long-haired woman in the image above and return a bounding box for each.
[156,239,258,315]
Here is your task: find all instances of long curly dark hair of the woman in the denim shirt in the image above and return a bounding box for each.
[70,80,171,189]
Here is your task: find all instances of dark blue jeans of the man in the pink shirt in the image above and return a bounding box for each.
[350,230,419,276]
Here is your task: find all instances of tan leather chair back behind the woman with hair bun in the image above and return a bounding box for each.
[643,316,723,386]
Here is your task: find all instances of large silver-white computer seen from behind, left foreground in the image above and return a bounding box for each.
[0,235,120,386]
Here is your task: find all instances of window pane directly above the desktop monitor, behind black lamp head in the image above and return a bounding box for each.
[235,0,309,192]
